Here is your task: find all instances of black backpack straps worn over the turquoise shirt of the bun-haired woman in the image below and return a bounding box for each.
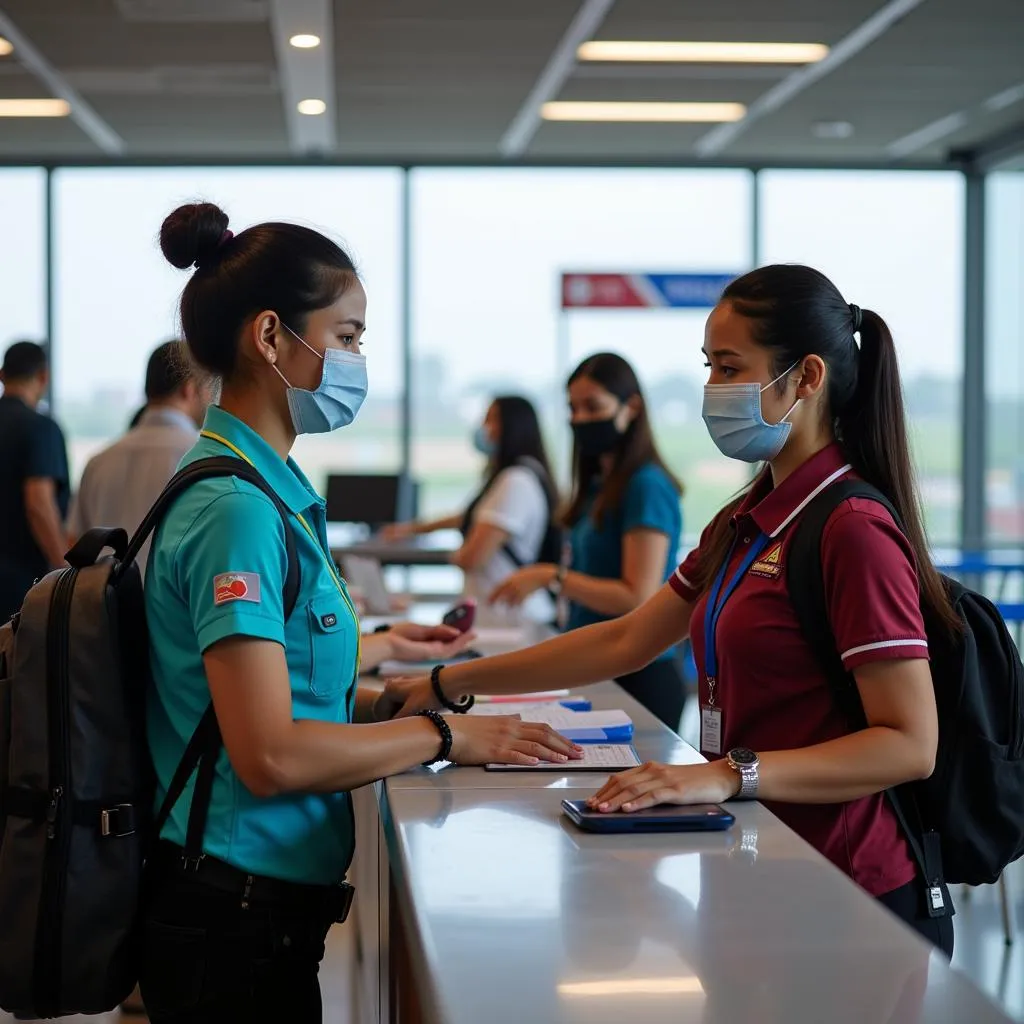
[144,456,301,862]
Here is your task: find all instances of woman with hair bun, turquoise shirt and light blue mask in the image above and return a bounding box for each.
[140,204,579,1024]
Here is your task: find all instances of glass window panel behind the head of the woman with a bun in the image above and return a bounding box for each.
[54,168,401,487]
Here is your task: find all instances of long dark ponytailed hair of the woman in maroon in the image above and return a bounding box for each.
[693,264,961,633]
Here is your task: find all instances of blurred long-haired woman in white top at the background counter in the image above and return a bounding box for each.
[383,395,561,623]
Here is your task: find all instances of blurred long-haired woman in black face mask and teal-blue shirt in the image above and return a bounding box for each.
[490,352,686,729]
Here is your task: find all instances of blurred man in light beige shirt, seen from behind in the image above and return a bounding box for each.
[69,341,211,579]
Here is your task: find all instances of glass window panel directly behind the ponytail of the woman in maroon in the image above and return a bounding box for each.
[760,171,964,546]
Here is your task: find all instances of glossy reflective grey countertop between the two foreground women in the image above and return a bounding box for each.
[381,683,1010,1024]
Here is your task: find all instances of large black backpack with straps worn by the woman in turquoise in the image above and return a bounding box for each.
[0,457,300,1017]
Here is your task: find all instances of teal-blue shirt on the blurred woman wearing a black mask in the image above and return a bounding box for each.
[565,463,683,660]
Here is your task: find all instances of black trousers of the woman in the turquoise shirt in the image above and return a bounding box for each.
[139,864,332,1024]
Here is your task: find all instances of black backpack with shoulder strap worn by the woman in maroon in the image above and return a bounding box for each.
[786,480,1024,901]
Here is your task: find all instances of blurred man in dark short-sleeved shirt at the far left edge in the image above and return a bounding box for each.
[0,341,70,623]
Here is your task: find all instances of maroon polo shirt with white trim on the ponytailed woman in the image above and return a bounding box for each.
[671,444,928,896]
